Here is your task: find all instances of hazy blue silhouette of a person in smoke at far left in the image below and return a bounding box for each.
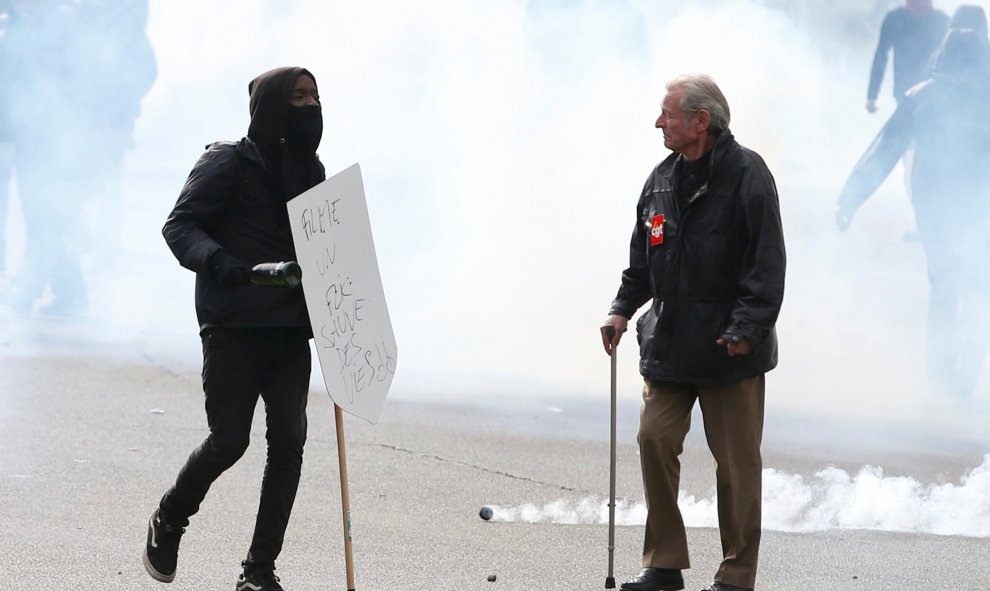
[4,0,156,316]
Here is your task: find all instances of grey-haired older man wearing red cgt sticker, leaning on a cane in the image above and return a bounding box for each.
[601,74,785,591]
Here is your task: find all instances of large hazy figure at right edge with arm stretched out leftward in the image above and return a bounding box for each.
[836,28,990,398]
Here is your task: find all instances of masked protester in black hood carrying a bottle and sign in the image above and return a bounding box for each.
[144,68,326,591]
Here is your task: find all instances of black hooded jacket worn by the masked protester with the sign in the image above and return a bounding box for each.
[162,68,326,331]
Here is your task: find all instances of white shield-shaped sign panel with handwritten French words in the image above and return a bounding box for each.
[288,164,396,423]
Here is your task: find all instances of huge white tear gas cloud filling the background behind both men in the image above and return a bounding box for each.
[6,0,990,434]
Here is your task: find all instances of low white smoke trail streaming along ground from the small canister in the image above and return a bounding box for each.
[484,454,990,538]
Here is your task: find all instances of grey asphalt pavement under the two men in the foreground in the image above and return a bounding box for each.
[0,327,990,591]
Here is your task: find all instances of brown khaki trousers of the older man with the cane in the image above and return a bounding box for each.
[638,374,766,589]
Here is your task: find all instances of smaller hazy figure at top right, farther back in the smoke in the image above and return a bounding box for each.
[866,0,949,113]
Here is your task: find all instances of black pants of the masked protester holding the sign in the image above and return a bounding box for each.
[160,328,311,566]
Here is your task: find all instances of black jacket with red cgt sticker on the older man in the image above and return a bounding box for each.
[611,131,785,384]
